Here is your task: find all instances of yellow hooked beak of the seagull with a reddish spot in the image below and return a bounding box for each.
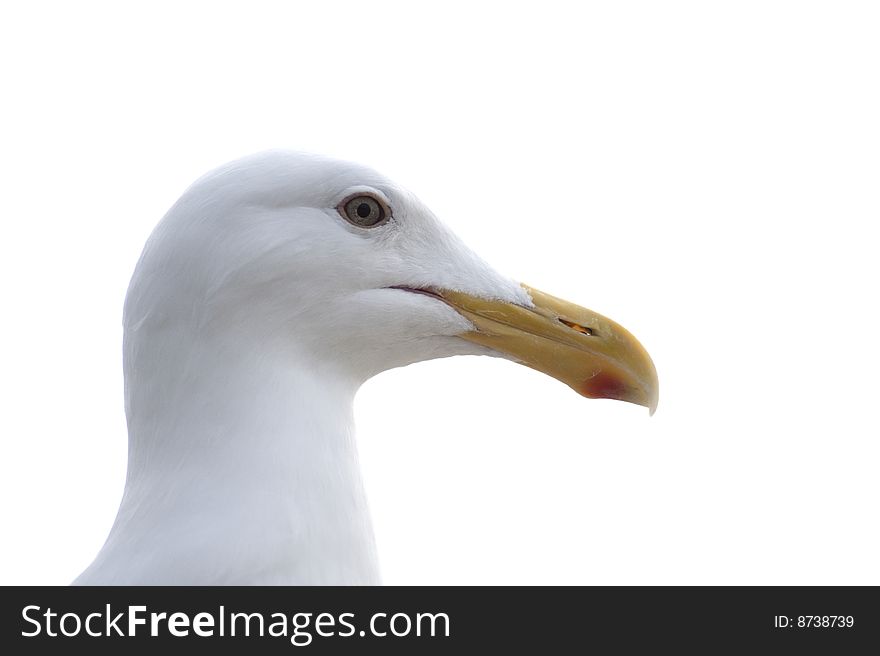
[435,285,659,414]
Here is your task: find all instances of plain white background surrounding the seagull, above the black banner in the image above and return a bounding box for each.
[0,1,880,585]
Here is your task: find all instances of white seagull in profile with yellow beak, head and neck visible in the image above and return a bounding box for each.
[74,151,658,585]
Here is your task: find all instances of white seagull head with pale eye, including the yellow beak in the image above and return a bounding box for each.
[124,151,658,412]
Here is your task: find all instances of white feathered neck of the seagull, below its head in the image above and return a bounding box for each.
[86,330,378,584]
